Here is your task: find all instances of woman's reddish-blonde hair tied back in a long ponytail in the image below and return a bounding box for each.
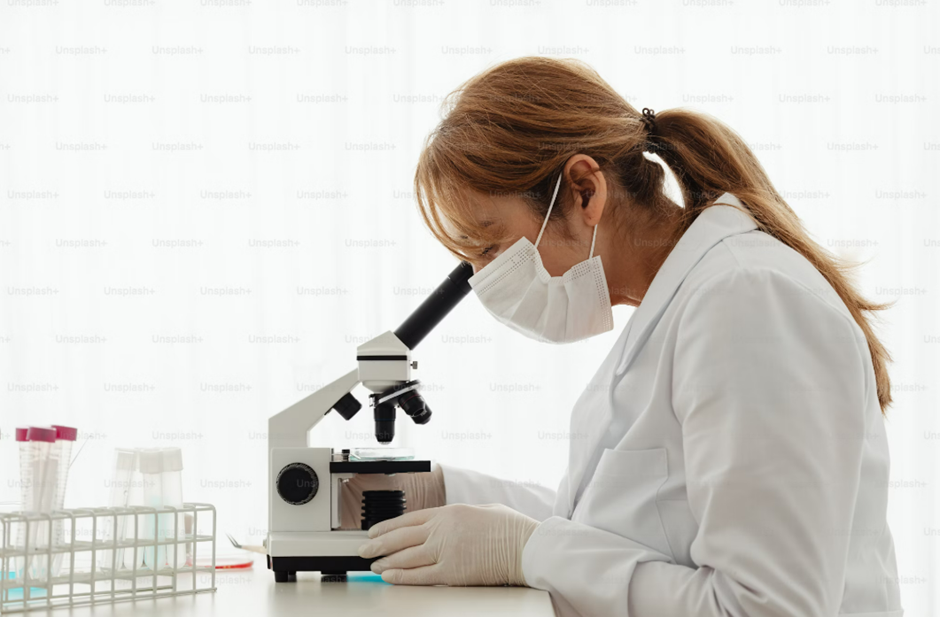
[414,57,891,412]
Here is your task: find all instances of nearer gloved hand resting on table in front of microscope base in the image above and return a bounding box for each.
[359,504,539,586]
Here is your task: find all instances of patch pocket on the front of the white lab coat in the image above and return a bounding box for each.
[572,448,675,561]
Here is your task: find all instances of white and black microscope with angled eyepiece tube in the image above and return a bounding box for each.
[265,262,473,583]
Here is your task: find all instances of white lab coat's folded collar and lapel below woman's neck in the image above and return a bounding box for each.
[616,193,757,376]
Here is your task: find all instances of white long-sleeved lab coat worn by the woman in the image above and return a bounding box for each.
[442,193,902,617]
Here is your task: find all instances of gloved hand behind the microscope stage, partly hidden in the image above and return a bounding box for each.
[340,465,446,530]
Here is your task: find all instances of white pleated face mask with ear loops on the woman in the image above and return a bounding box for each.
[469,175,614,343]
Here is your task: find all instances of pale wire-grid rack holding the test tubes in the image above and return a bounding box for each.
[0,503,216,614]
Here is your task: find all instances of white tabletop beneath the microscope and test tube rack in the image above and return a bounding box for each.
[27,556,555,617]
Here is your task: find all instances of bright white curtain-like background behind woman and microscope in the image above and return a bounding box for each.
[0,0,940,615]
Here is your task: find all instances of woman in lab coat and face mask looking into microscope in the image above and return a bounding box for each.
[347,58,902,617]
